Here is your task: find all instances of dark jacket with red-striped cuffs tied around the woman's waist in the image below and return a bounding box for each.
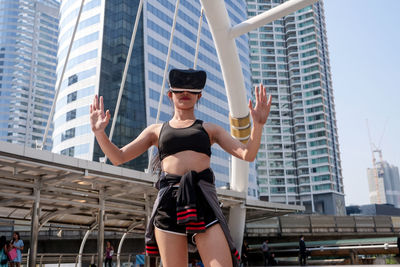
[145,168,240,266]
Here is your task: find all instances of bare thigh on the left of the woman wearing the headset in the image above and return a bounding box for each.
[155,228,188,267]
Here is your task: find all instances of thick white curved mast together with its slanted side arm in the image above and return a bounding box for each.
[200,0,317,249]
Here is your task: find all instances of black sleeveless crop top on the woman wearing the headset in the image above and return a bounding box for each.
[158,120,211,161]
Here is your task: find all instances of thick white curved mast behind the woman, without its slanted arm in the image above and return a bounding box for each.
[200,0,249,252]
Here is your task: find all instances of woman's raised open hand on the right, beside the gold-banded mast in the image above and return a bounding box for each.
[249,84,272,125]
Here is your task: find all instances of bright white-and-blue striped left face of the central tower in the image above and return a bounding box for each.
[53,0,105,159]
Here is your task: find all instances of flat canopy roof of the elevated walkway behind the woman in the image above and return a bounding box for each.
[0,142,304,232]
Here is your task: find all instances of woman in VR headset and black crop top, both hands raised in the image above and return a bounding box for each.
[90,69,271,267]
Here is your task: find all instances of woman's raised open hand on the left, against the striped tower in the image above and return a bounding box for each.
[90,95,111,133]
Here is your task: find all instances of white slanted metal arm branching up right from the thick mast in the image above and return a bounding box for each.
[230,0,318,38]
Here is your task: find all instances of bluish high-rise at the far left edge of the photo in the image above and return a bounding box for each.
[0,0,60,150]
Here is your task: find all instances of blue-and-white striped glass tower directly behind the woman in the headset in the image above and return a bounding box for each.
[53,0,257,197]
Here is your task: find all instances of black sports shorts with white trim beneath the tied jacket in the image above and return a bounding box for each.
[154,185,218,236]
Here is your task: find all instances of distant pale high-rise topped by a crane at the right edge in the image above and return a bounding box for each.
[367,161,400,208]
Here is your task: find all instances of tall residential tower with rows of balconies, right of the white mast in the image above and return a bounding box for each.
[247,0,345,215]
